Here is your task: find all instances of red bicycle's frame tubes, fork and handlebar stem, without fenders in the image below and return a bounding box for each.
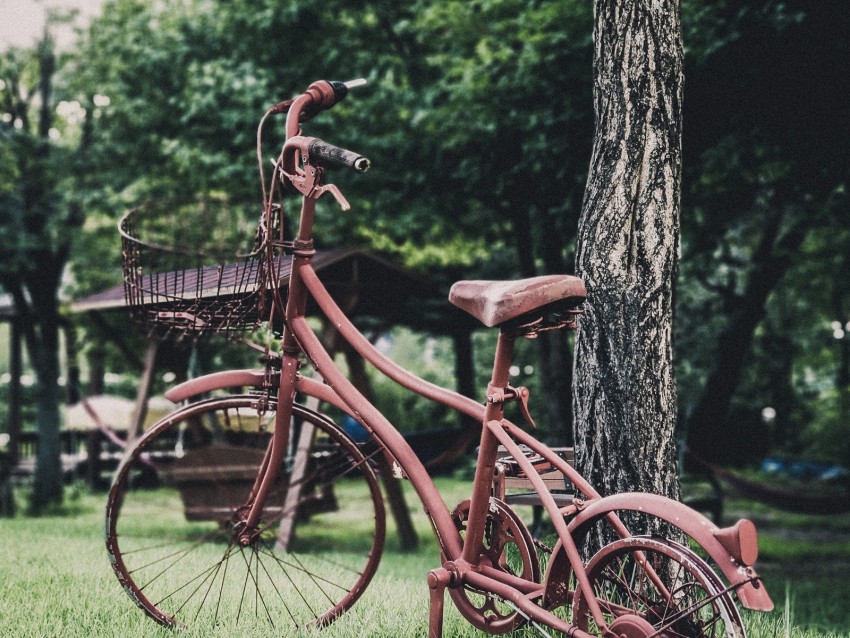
[211,83,604,630]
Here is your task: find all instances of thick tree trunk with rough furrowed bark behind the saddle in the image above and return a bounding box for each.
[574,0,683,498]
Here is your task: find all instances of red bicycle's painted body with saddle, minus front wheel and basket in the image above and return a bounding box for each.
[109,82,772,638]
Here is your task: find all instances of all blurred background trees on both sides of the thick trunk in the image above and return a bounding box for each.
[0,0,850,510]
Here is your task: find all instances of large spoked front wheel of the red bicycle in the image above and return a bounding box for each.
[106,395,385,635]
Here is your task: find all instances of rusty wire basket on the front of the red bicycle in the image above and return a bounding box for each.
[119,200,268,339]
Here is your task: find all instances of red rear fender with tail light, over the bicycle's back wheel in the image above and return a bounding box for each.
[546,492,773,611]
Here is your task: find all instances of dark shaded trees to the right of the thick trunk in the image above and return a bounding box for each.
[677,1,850,470]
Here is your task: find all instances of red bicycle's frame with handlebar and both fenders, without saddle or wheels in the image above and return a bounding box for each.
[156,83,772,636]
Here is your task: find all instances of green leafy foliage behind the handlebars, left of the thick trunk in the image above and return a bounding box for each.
[64,0,591,440]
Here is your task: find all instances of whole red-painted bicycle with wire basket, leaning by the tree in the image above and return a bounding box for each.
[106,81,773,638]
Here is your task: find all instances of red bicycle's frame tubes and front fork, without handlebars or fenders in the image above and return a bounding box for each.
[246,248,602,630]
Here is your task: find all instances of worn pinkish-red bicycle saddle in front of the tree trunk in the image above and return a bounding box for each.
[449,275,587,328]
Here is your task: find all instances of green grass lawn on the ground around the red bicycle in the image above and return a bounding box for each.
[0,479,850,638]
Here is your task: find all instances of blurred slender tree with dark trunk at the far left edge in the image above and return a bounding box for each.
[0,23,88,512]
